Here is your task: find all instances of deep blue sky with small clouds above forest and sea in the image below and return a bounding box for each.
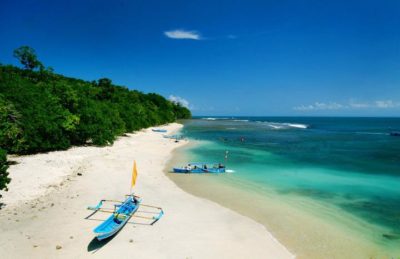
[0,0,400,116]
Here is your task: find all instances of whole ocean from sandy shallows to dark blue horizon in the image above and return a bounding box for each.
[171,117,400,258]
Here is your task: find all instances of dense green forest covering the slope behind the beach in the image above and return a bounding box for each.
[0,46,191,193]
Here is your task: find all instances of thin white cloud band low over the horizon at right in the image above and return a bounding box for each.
[293,100,400,111]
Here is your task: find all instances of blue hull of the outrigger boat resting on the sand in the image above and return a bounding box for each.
[93,196,140,240]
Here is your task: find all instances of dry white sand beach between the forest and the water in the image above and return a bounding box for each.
[0,123,294,259]
